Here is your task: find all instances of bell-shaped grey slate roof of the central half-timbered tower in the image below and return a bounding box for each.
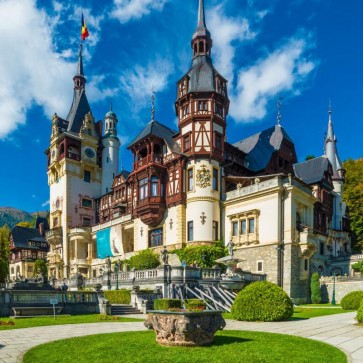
[187,55,223,93]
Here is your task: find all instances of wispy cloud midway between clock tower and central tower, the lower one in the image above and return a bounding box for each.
[120,59,174,108]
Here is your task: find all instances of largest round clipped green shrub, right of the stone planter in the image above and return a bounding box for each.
[231,281,294,321]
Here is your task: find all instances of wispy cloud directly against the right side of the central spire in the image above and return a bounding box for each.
[208,4,256,84]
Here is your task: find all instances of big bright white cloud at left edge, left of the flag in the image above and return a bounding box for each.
[0,0,74,139]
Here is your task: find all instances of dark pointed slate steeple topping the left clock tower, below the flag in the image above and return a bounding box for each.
[67,44,91,133]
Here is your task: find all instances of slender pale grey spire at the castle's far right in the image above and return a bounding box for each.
[324,102,345,180]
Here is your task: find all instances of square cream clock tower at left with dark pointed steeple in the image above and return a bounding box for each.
[46,45,102,278]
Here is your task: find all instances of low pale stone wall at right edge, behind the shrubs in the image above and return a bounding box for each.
[320,277,363,304]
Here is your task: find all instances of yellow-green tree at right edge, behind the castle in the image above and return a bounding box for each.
[343,158,363,252]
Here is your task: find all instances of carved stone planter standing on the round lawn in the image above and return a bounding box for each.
[144,310,226,346]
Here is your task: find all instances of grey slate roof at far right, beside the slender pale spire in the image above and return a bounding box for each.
[293,155,330,184]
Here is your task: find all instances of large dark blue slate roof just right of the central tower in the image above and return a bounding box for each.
[233,125,294,172]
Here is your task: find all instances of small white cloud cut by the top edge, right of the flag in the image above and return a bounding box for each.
[111,0,168,23]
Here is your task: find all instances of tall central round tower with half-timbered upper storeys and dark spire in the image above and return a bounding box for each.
[175,0,229,243]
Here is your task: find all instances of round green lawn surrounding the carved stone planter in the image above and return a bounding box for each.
[23,331,346,363]
